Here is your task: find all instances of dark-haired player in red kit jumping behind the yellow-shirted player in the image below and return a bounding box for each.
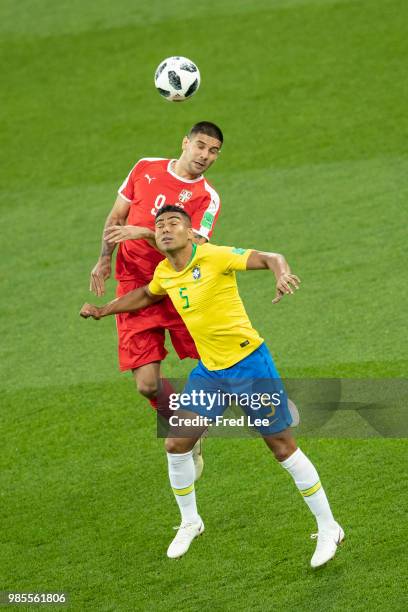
[90,121,223,470]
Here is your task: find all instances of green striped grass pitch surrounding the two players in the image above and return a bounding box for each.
[0,0,408,612]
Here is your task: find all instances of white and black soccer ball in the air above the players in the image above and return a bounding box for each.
[154,56,200,102]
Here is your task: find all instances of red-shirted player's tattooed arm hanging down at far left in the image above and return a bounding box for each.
[89,195,130,297]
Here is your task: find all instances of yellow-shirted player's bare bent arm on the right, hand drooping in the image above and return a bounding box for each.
[247,251,300,304]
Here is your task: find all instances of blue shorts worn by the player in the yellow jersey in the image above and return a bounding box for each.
[180,344,292,436]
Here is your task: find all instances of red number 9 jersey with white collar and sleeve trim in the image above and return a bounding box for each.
[116,158,220,286]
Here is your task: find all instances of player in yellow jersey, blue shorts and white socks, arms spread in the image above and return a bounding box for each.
[80,206,344,567]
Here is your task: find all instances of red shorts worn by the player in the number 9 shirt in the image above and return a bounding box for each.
[116,281,200,371]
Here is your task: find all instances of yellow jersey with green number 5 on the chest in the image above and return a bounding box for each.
[149,243,263,370]
